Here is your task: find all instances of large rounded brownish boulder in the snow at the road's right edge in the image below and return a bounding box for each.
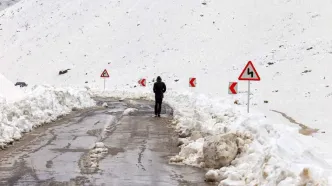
[203,133,238,169]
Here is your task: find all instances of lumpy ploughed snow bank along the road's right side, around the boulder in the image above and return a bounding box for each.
[91,91,331,186]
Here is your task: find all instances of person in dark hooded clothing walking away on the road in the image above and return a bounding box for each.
[153,76,166,117]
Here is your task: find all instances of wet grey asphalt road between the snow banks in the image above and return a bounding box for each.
[0,98,213,186]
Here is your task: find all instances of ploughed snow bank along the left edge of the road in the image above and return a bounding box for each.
[0,86,95,147]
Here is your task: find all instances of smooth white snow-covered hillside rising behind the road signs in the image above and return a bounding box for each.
[0,0,332,183]
